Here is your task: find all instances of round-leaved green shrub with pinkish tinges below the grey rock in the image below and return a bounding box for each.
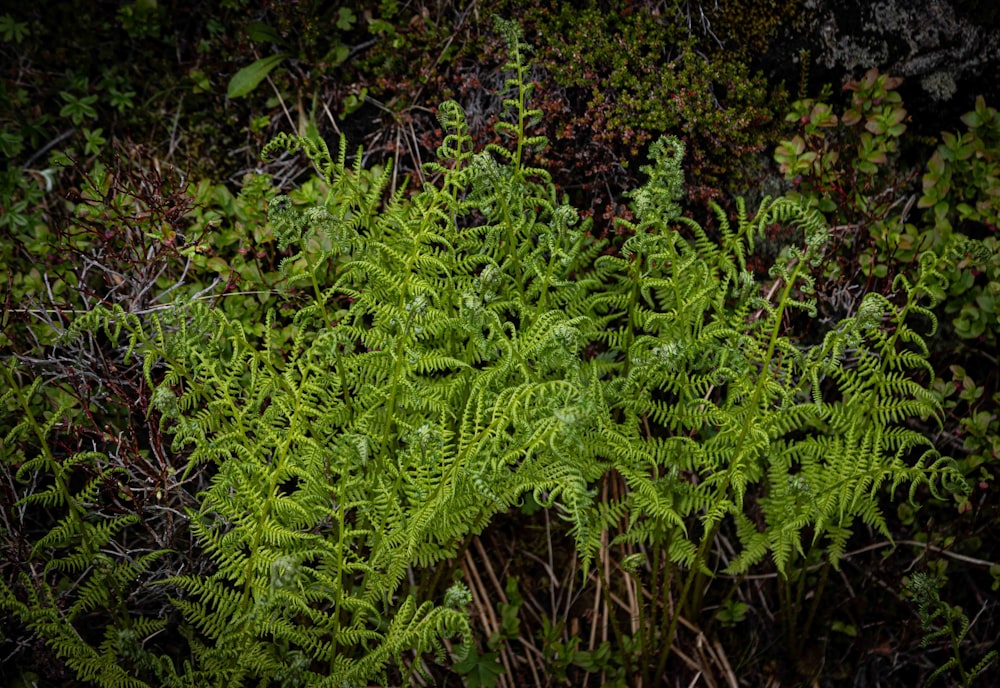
[774,69,1000,345]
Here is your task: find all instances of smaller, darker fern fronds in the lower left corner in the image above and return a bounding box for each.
[0,359,165,686]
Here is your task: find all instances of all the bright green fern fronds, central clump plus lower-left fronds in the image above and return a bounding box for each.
[0,22,963,686]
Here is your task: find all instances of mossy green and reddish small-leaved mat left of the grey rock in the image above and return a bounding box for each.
[492,2,783,220]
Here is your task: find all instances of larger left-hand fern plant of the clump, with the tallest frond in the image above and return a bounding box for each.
[7,18,599,685]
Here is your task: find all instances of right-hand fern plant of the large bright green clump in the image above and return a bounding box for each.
[584,132,964,675]
